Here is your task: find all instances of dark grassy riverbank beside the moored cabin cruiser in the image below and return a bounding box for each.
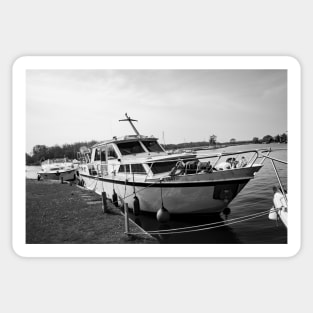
[26,179,157,244]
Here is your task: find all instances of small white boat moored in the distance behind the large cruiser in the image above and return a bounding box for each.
[37,158,78,181]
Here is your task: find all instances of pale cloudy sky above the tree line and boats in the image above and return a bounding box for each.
[26,70,287,152]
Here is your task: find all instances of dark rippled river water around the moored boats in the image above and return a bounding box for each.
[26,144,287,244]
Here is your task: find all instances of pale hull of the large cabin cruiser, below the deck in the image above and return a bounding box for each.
[80,166,261,214]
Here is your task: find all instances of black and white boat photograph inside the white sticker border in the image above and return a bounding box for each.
[14,58,298,256]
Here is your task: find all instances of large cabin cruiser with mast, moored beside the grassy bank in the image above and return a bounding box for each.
[78,114,263,214]
